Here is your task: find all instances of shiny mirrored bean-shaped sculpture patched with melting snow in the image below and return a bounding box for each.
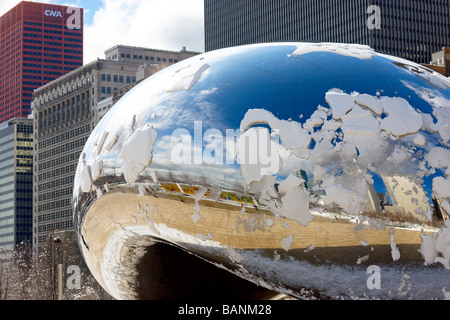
[73,43,450,299]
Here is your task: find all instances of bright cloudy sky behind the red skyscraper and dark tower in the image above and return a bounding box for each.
[0,0,204,64]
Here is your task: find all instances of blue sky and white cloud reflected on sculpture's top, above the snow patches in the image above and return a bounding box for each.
[89,45,448,145]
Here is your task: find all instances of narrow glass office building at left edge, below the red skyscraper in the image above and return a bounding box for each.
[0,119,33,251]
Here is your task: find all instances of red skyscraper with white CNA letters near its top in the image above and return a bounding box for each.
[0,1,83,123]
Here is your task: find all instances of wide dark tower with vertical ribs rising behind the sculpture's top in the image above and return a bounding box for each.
[204,0,450,63]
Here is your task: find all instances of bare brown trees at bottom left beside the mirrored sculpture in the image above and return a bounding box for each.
[0,232,112,300]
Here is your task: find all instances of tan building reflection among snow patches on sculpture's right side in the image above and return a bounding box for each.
[383,176,428,220]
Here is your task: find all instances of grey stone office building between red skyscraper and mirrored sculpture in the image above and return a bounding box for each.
[33,46,198,252]
